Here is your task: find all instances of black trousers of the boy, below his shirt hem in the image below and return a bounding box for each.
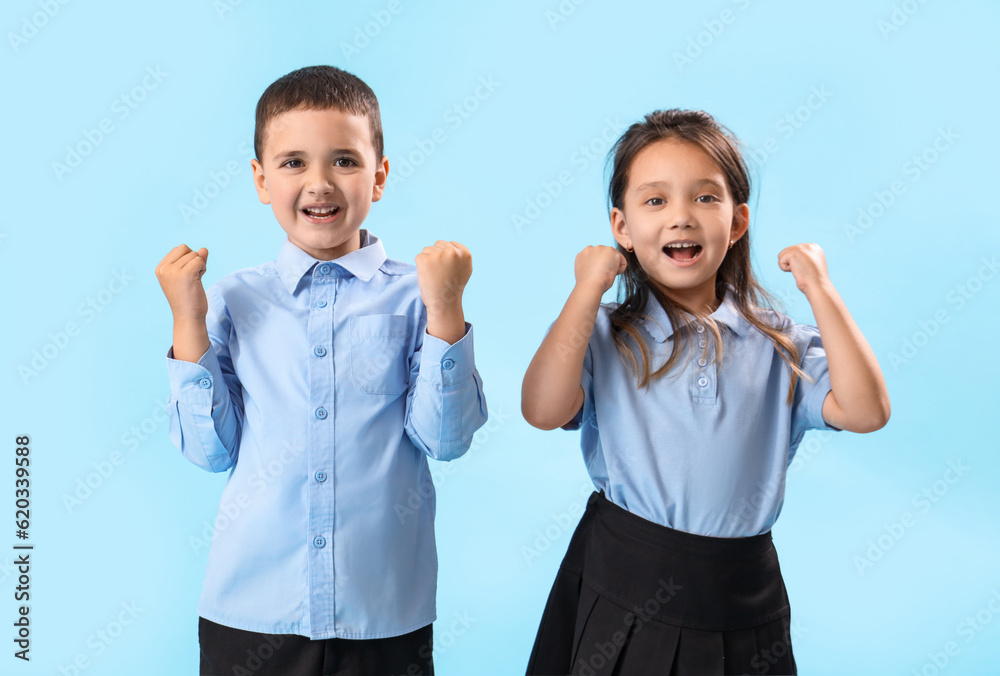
[198,617,434,676]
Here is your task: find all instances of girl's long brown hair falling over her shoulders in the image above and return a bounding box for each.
[608,108,808,403]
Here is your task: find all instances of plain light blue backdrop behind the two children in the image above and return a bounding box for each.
[0,0,1000,676]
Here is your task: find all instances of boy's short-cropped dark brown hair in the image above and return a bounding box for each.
[253,66,384,162]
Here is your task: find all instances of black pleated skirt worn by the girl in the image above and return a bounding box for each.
[527,493,797,676]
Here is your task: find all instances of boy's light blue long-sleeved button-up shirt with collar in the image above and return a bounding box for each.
[167,230,487,639]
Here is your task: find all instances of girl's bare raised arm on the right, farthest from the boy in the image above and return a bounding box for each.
[778,244,889,433]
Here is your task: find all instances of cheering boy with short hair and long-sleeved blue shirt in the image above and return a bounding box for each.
[156,66,486,676]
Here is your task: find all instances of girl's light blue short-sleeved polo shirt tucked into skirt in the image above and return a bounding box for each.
[564,296,836,537]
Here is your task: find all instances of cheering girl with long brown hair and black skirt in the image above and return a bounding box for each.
[521,110,889,675]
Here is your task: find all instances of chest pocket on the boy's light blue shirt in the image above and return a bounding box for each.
[350,315,410,394]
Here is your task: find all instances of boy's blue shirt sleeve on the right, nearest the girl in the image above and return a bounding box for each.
[405,322,487,460]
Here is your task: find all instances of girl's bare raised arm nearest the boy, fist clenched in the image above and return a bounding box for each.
[521,246,626,430]
